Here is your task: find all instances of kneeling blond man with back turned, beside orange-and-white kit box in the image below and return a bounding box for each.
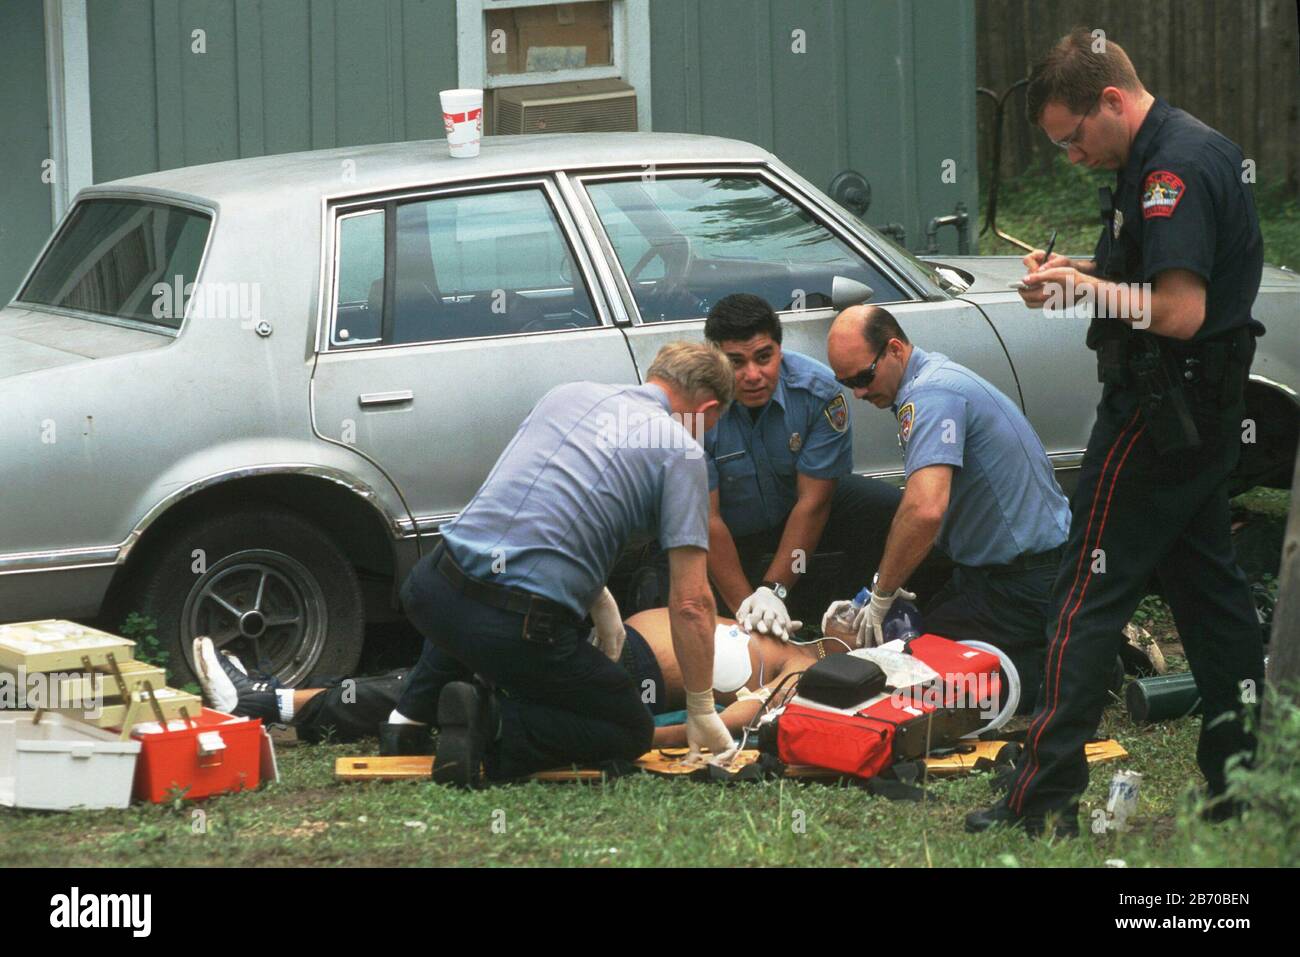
[385,342,733,787]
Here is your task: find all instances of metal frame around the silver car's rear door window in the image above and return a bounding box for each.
[316,174,615,355]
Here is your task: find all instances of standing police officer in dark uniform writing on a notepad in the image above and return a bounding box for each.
[966,29,1264,833]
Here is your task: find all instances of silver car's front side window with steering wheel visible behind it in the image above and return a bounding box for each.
[586,176,910,322]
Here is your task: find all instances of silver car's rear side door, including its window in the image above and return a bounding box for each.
[312,177,637,538]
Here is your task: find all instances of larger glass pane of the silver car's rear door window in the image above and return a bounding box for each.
[386,189,599,343]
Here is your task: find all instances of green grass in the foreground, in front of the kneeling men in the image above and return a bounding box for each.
[0,709,1300,867]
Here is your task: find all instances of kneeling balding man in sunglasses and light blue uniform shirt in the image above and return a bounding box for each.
[822,306,1070,711]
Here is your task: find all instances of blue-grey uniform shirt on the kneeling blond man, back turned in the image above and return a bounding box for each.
[442,382,709,616]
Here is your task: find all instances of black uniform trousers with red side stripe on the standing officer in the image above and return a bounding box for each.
[1009,386,1264,814]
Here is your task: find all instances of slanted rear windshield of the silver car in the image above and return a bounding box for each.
[18,199,212,329]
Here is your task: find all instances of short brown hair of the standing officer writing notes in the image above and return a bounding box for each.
[1024,26,1141,126]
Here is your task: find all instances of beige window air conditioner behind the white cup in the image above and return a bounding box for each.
[493,79,637,134]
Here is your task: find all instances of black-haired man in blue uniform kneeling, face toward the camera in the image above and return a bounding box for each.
[705,293,900,638]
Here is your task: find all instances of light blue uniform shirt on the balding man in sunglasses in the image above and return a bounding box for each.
[893,347,1070,566]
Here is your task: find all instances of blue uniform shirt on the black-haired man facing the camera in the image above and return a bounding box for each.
[705,351,853,536]
